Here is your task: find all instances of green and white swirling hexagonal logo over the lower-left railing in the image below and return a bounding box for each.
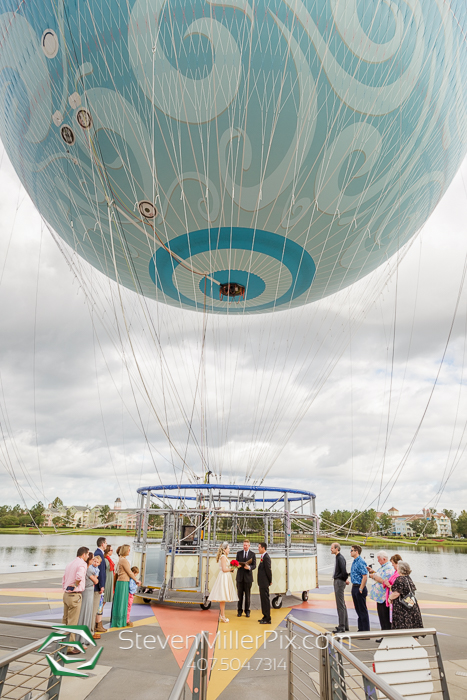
[38,625,103,678]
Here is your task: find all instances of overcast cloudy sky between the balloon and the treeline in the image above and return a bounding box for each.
[0,146,467,512]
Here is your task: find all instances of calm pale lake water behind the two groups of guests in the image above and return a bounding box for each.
[0,533,467,588]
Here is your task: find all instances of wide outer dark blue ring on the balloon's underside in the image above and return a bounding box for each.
[149,226,316,313]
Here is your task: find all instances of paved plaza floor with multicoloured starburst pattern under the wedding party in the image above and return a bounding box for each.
[0,571,467,700]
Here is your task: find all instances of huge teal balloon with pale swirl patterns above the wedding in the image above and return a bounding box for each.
[0,0,467,313]
